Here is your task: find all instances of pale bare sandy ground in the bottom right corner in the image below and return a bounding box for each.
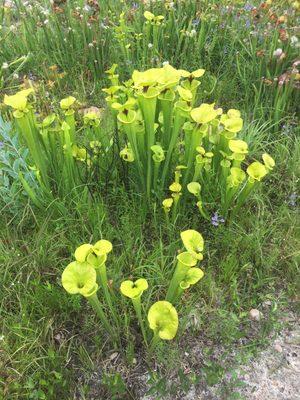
[141,313,300,400]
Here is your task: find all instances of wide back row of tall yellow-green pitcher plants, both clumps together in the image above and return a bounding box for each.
[4,64,275,223]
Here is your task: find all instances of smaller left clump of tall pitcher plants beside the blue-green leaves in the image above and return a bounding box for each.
[4,88,111,208]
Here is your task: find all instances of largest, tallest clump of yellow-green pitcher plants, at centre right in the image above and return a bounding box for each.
[103,64,275,222]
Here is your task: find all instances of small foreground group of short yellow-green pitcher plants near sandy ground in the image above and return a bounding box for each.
[62,230,204,350]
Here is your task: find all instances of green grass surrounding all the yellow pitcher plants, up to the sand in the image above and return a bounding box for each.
[0,0,300,400]
